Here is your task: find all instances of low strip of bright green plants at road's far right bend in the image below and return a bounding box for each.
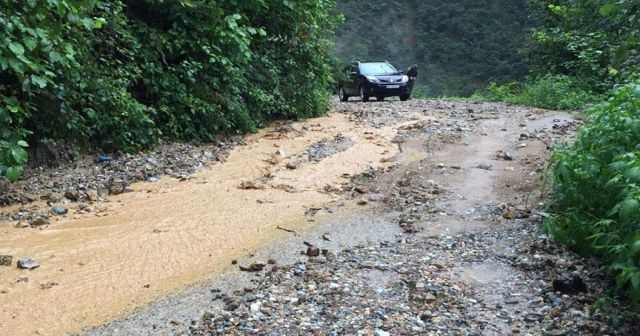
[472,75,600,110]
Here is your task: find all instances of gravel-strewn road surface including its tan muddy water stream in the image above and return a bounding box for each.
[0,100,633,335]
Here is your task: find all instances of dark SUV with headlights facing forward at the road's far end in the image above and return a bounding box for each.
[339,61,413,102]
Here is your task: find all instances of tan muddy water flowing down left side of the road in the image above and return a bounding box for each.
[0,114,398,335]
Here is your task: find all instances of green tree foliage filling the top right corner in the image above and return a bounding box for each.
[528,0,640,92]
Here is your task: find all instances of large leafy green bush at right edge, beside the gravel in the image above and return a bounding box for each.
[545,83,640,304]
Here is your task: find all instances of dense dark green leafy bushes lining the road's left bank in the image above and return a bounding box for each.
[0,0,339,179]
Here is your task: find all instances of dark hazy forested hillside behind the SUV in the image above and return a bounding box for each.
[336,0,530,96]
